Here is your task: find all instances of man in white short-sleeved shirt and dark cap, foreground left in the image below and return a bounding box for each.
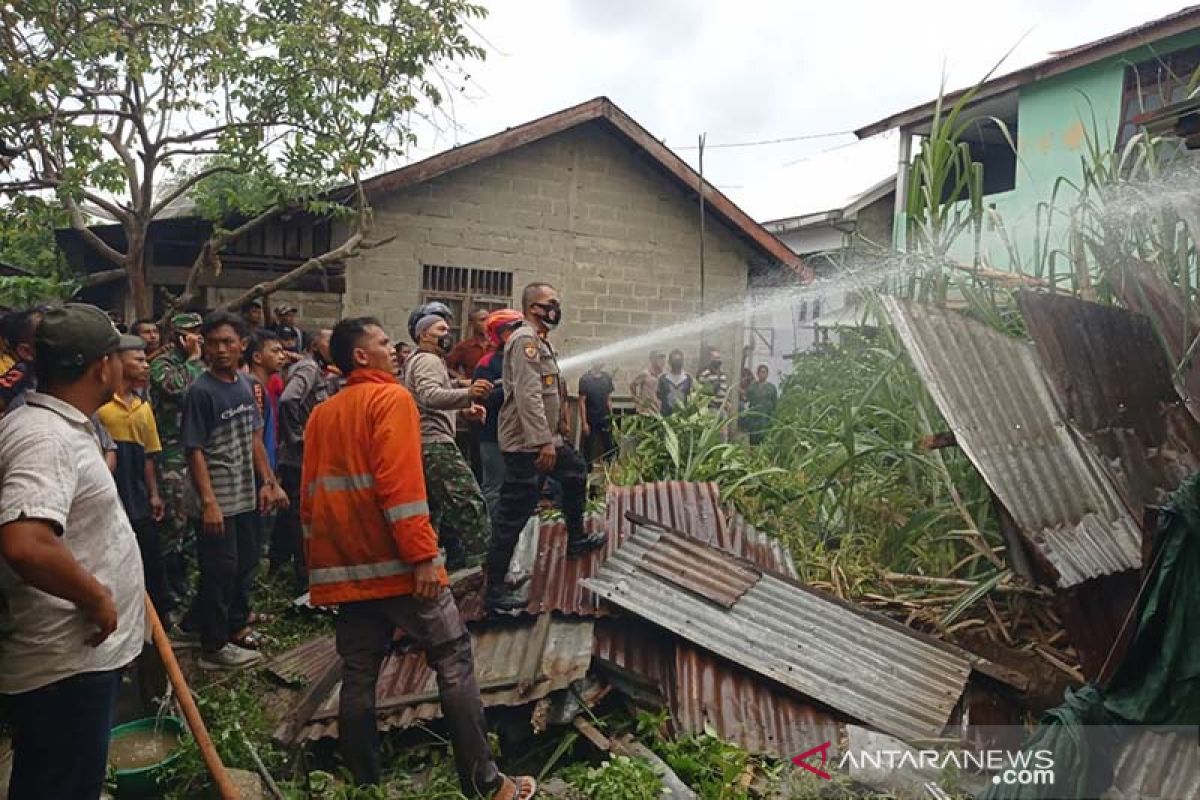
[0,303,145,800]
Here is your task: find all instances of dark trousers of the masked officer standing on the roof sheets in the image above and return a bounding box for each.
[487,444,587,591]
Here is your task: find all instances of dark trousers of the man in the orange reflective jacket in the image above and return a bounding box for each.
[334,589,500,796]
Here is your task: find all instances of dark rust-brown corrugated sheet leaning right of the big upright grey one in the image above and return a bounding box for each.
[1016,291,1200,519]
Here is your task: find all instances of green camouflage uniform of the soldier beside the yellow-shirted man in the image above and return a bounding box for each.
[150,335,204,573]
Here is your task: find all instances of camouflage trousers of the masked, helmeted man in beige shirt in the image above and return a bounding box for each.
[421,441,491,564]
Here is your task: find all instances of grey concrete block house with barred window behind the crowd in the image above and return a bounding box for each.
[62,97,804,393]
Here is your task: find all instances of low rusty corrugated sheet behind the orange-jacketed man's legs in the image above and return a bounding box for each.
[284,614,593,739]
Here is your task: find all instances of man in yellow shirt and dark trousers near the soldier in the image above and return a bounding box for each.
[96,335,173,619]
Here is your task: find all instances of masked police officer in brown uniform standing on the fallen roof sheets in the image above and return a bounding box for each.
[487,283,607,612]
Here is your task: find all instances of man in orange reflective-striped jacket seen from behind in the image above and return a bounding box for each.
[300,317,536,800]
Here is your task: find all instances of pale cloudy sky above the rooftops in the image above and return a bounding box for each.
[413,0,1183,219]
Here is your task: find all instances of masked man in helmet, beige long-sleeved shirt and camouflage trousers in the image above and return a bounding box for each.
[403,314,492,570]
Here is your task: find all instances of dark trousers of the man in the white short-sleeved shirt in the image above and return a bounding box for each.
[8,669,121,800]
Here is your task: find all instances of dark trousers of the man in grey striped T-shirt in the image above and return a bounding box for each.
[185,511,263,652]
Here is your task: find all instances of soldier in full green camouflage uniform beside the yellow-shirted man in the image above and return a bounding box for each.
[150,312,204,601]
